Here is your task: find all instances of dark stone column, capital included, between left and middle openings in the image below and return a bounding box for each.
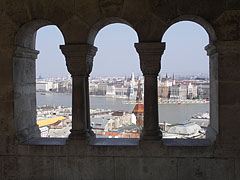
[60,44,97,140]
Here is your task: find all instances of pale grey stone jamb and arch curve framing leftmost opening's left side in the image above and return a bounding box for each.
[13,20,66,142]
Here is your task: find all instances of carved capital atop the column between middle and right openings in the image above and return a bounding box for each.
[135,42,165,75]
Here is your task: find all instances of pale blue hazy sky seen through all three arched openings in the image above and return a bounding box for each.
[36,22,209,77]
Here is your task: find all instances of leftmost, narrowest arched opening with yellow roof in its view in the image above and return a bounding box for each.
[36,25,72,138]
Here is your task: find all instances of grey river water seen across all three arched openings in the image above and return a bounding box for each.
[37,93,209,124]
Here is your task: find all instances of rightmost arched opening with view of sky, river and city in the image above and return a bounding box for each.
[158,21,215,139]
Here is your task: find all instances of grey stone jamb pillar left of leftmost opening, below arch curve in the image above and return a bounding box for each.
[13,46,40,142]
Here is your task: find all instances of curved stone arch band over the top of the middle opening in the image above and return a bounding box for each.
[87,17,139,45]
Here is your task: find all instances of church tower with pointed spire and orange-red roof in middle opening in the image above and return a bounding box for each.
[133,80,144,131]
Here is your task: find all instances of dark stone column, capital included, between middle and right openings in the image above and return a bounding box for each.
[135,42,165,140]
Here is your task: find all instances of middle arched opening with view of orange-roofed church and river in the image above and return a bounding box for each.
[89,21,143,138]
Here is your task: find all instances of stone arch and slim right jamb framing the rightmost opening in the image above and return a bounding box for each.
[162,15,219,142]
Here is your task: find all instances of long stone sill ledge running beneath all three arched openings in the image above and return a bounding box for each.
[11,138,240,158]
